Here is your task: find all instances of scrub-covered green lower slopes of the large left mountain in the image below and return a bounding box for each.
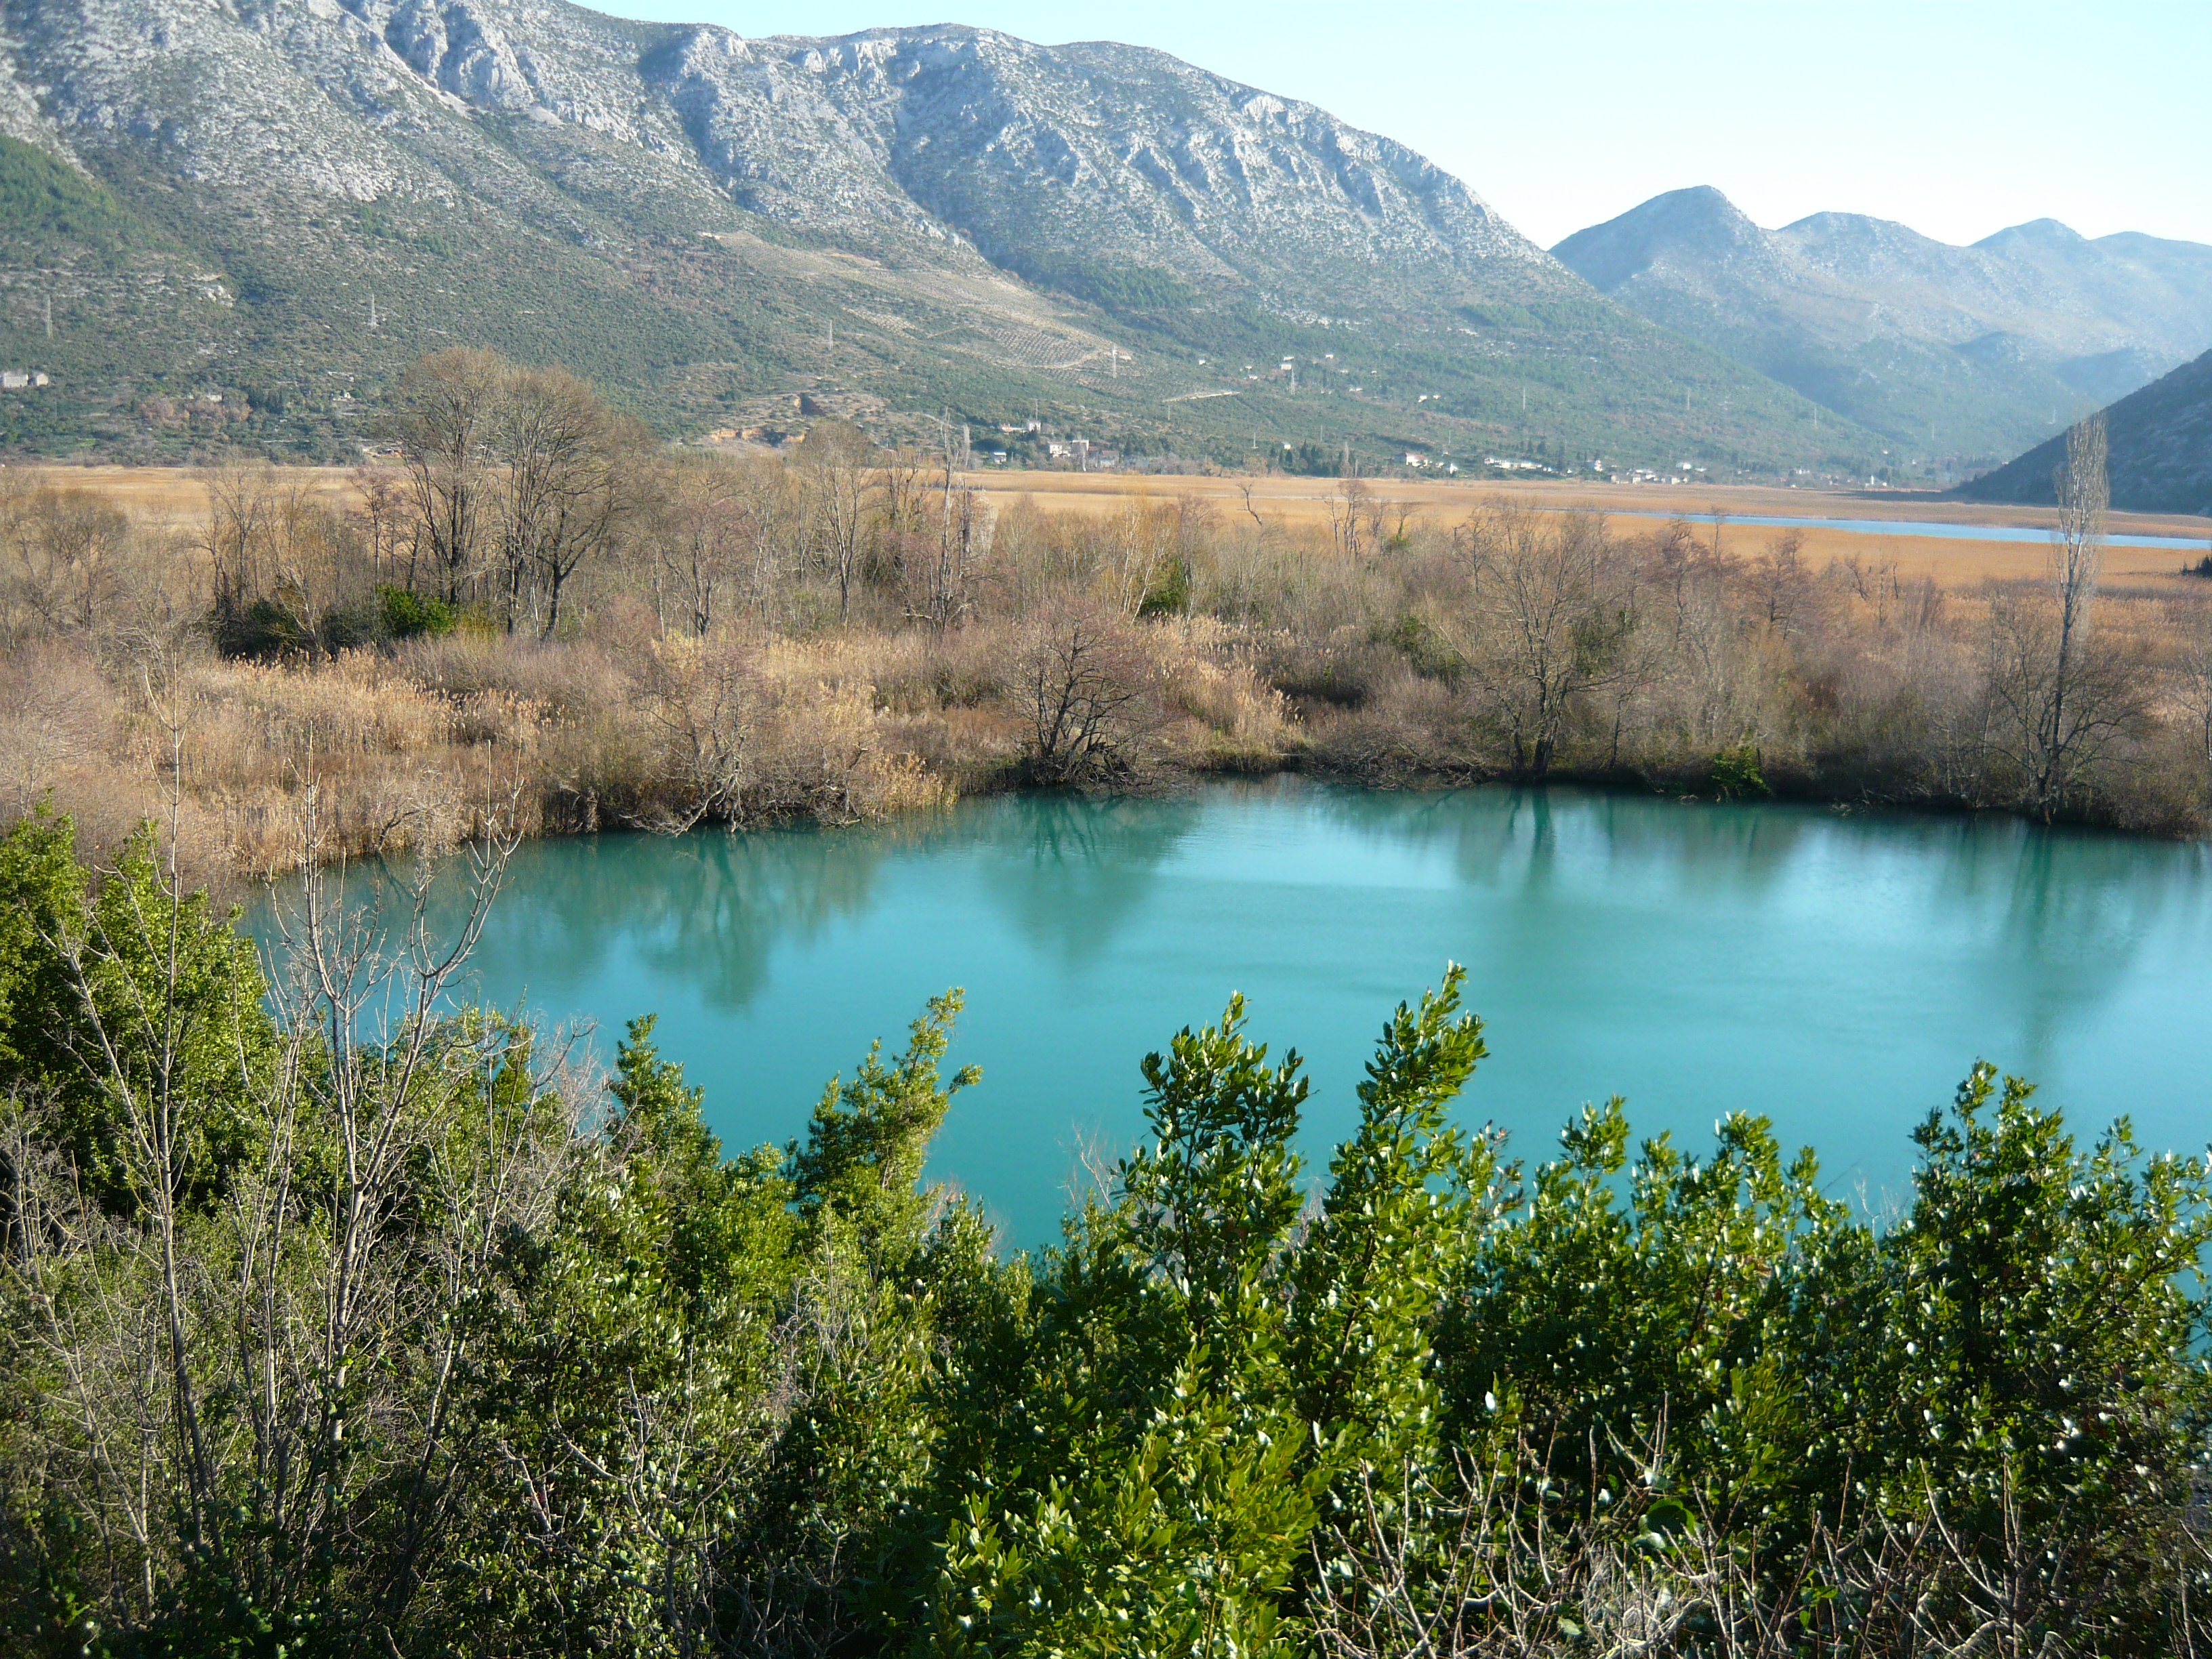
[0,92,1880,478]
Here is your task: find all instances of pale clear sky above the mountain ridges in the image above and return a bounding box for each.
[579,0,2212,248]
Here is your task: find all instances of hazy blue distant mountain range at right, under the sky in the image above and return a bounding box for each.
[1553,186,2212,467]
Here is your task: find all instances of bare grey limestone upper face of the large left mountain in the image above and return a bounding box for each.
[0,0,1575,314]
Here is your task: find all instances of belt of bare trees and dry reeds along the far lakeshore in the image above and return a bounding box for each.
[0,352,2212,898]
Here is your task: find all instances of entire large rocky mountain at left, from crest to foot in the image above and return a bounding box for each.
[0,0,1878,476]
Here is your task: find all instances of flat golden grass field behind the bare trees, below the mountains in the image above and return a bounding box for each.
[21,467,2212,590]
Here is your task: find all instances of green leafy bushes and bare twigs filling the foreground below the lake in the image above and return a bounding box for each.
[0,821,2212,1654]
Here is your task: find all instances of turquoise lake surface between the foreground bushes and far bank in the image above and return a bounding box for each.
[289,779,2212,1243]
